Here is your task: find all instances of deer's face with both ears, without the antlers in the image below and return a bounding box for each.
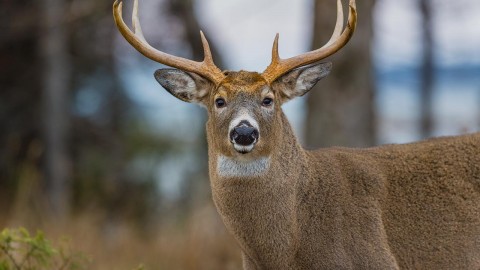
[155,63,331,158]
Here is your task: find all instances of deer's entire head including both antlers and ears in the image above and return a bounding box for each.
[114,0,357,158]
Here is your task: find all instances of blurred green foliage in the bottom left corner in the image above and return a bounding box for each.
[0,228,88,270]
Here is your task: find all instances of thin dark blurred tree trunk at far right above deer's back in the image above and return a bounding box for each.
[419,0,434,138]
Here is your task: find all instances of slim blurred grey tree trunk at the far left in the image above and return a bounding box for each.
[40,0,71,219]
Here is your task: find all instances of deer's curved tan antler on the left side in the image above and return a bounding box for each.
[113,0,225,84]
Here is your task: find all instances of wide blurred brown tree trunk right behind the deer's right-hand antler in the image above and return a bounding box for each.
[305,0,375,148]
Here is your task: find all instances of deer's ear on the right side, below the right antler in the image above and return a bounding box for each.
[272,62,332,102]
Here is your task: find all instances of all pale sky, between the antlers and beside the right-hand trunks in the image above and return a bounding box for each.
[197,0,480,71]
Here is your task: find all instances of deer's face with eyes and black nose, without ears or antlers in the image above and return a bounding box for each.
[207,71,274,156]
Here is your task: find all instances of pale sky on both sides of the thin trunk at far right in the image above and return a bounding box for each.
[374,0,480,65]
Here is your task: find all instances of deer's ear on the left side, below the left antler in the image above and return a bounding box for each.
[154,68,212,104]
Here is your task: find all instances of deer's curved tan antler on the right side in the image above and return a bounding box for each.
[262,0,357,83]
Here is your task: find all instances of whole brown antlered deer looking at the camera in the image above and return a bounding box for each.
[114,0,480,269]
